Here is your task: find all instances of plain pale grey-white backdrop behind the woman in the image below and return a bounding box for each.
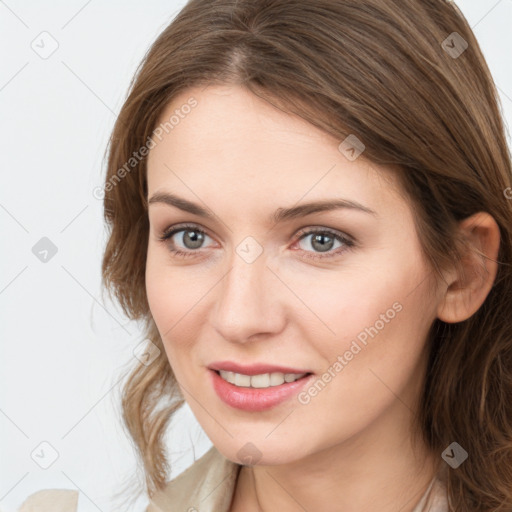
[0,0,512,512]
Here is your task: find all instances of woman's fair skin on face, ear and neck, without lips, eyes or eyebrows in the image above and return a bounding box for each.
[146,86,499,512]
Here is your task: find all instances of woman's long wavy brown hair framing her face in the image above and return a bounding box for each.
[102,0,512,512]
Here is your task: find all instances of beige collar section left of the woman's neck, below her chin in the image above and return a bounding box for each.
[146,446,241,512]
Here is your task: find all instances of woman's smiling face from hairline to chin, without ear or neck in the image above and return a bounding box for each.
[146,86,441,464]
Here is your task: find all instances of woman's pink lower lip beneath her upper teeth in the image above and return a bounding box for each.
[208,370,313,412]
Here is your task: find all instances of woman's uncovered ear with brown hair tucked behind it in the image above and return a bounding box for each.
[437,212,500,323]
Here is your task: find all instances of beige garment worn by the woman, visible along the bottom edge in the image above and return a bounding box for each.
[18,446,448,512]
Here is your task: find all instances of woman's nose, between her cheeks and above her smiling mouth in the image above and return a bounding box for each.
[211,245,286,343]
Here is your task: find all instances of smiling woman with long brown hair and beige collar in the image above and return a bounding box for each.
[17,0,512,512]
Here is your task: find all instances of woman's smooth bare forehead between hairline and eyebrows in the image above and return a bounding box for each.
[148,86,401,216]
